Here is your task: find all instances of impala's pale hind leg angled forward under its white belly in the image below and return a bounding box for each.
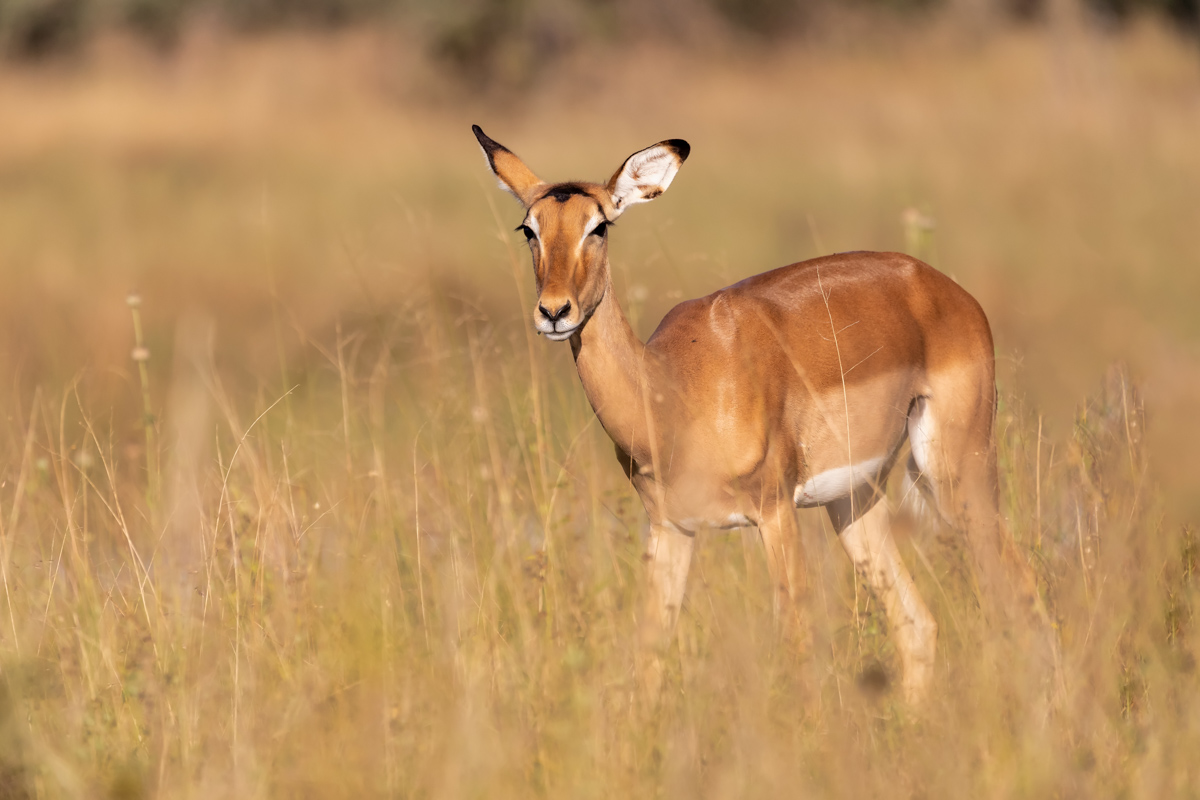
[826,487,937,705]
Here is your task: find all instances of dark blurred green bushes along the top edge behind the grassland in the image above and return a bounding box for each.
[0,0,1200,65]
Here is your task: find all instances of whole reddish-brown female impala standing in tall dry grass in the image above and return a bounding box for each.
[473,126,1038,700]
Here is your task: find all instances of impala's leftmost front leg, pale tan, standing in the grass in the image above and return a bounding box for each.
[638,524,695,697]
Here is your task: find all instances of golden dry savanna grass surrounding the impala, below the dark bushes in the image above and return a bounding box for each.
[0,18,1200,798]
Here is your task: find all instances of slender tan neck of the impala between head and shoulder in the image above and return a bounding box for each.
[571,278,662,465]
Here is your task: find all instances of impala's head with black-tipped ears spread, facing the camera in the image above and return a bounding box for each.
[472,125,691,342]
